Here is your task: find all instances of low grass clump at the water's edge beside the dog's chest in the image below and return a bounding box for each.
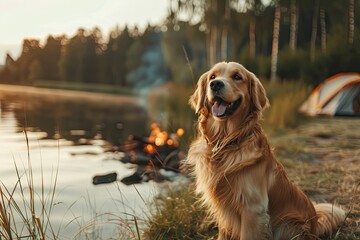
[143,183,216,240]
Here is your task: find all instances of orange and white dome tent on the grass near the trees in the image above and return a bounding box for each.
[299,73,360,116]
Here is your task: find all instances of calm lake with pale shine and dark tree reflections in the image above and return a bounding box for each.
[0,86,192,239]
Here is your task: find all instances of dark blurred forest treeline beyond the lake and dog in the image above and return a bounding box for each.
[0,0,360,88]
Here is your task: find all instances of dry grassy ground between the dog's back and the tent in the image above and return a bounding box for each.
[269,118,360,239]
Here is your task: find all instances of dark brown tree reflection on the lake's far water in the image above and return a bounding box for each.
[0,91,148,144]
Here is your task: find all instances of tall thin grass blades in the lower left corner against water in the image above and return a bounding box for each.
[0,131,58,240]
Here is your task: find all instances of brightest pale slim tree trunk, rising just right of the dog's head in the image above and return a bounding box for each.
[270,3,281,82]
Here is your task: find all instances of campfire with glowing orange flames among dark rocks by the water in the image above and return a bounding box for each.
[93,123,185,185]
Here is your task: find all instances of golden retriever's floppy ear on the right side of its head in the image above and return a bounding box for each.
[249,73,270,113]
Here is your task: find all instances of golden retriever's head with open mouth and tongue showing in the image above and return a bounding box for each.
[189,62,269,122]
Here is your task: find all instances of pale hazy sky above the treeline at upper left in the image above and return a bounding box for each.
[0,0,170,65]
